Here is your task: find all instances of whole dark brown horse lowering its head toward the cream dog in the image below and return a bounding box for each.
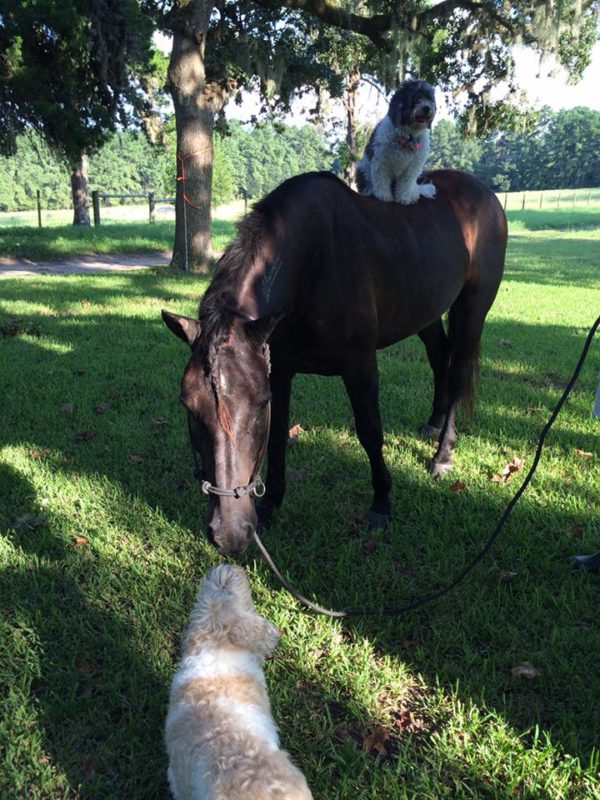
[163,170,507,554]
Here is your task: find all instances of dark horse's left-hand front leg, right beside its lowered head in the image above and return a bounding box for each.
[256,367,293,528]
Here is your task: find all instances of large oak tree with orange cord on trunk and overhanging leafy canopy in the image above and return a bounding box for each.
[145,0,597,268]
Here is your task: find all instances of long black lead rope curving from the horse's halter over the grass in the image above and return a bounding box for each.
[254,317,600,617]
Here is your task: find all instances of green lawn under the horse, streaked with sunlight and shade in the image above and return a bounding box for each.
[0,209,600,800]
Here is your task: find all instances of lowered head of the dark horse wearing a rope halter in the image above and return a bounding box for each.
[162,311,271,555]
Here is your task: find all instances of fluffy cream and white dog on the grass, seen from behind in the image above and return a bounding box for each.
[165,564,312,800]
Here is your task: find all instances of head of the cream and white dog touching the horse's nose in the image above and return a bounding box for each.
[183,564,281,659]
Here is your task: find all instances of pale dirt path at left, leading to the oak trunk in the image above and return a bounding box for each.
[0,250,171,279]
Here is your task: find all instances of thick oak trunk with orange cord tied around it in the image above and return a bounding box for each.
[168,0,227,271]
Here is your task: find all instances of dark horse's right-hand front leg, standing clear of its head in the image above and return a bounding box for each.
[342,360,392,528]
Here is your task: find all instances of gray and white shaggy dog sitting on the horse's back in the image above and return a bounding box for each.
[356,80,436,205]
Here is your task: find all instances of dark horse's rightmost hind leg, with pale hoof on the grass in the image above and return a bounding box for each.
[430,296,490,477]
